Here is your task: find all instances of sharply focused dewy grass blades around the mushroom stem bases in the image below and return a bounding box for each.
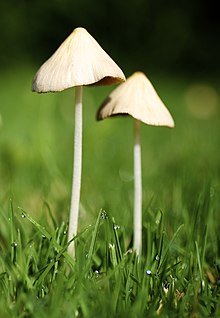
[0,183,220,317]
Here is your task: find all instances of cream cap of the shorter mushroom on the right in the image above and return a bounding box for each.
[97,72,174,127]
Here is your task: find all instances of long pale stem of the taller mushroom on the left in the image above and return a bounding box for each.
[68,86,83,257]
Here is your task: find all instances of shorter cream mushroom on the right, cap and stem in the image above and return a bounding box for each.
[97,72,174,255]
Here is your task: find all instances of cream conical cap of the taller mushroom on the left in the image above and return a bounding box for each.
[32,28,125,93]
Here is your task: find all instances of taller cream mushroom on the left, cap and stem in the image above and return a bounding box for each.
[32,27,125,257]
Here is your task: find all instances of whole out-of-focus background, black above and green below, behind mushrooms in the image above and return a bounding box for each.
[0,0,220,228]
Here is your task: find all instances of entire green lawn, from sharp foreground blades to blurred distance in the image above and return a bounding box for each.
[0,67,220,318]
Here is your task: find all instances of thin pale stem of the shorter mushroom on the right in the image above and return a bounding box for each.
[133,119,142,255]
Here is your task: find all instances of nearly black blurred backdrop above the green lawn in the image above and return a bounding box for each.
[0,0,220,76]
